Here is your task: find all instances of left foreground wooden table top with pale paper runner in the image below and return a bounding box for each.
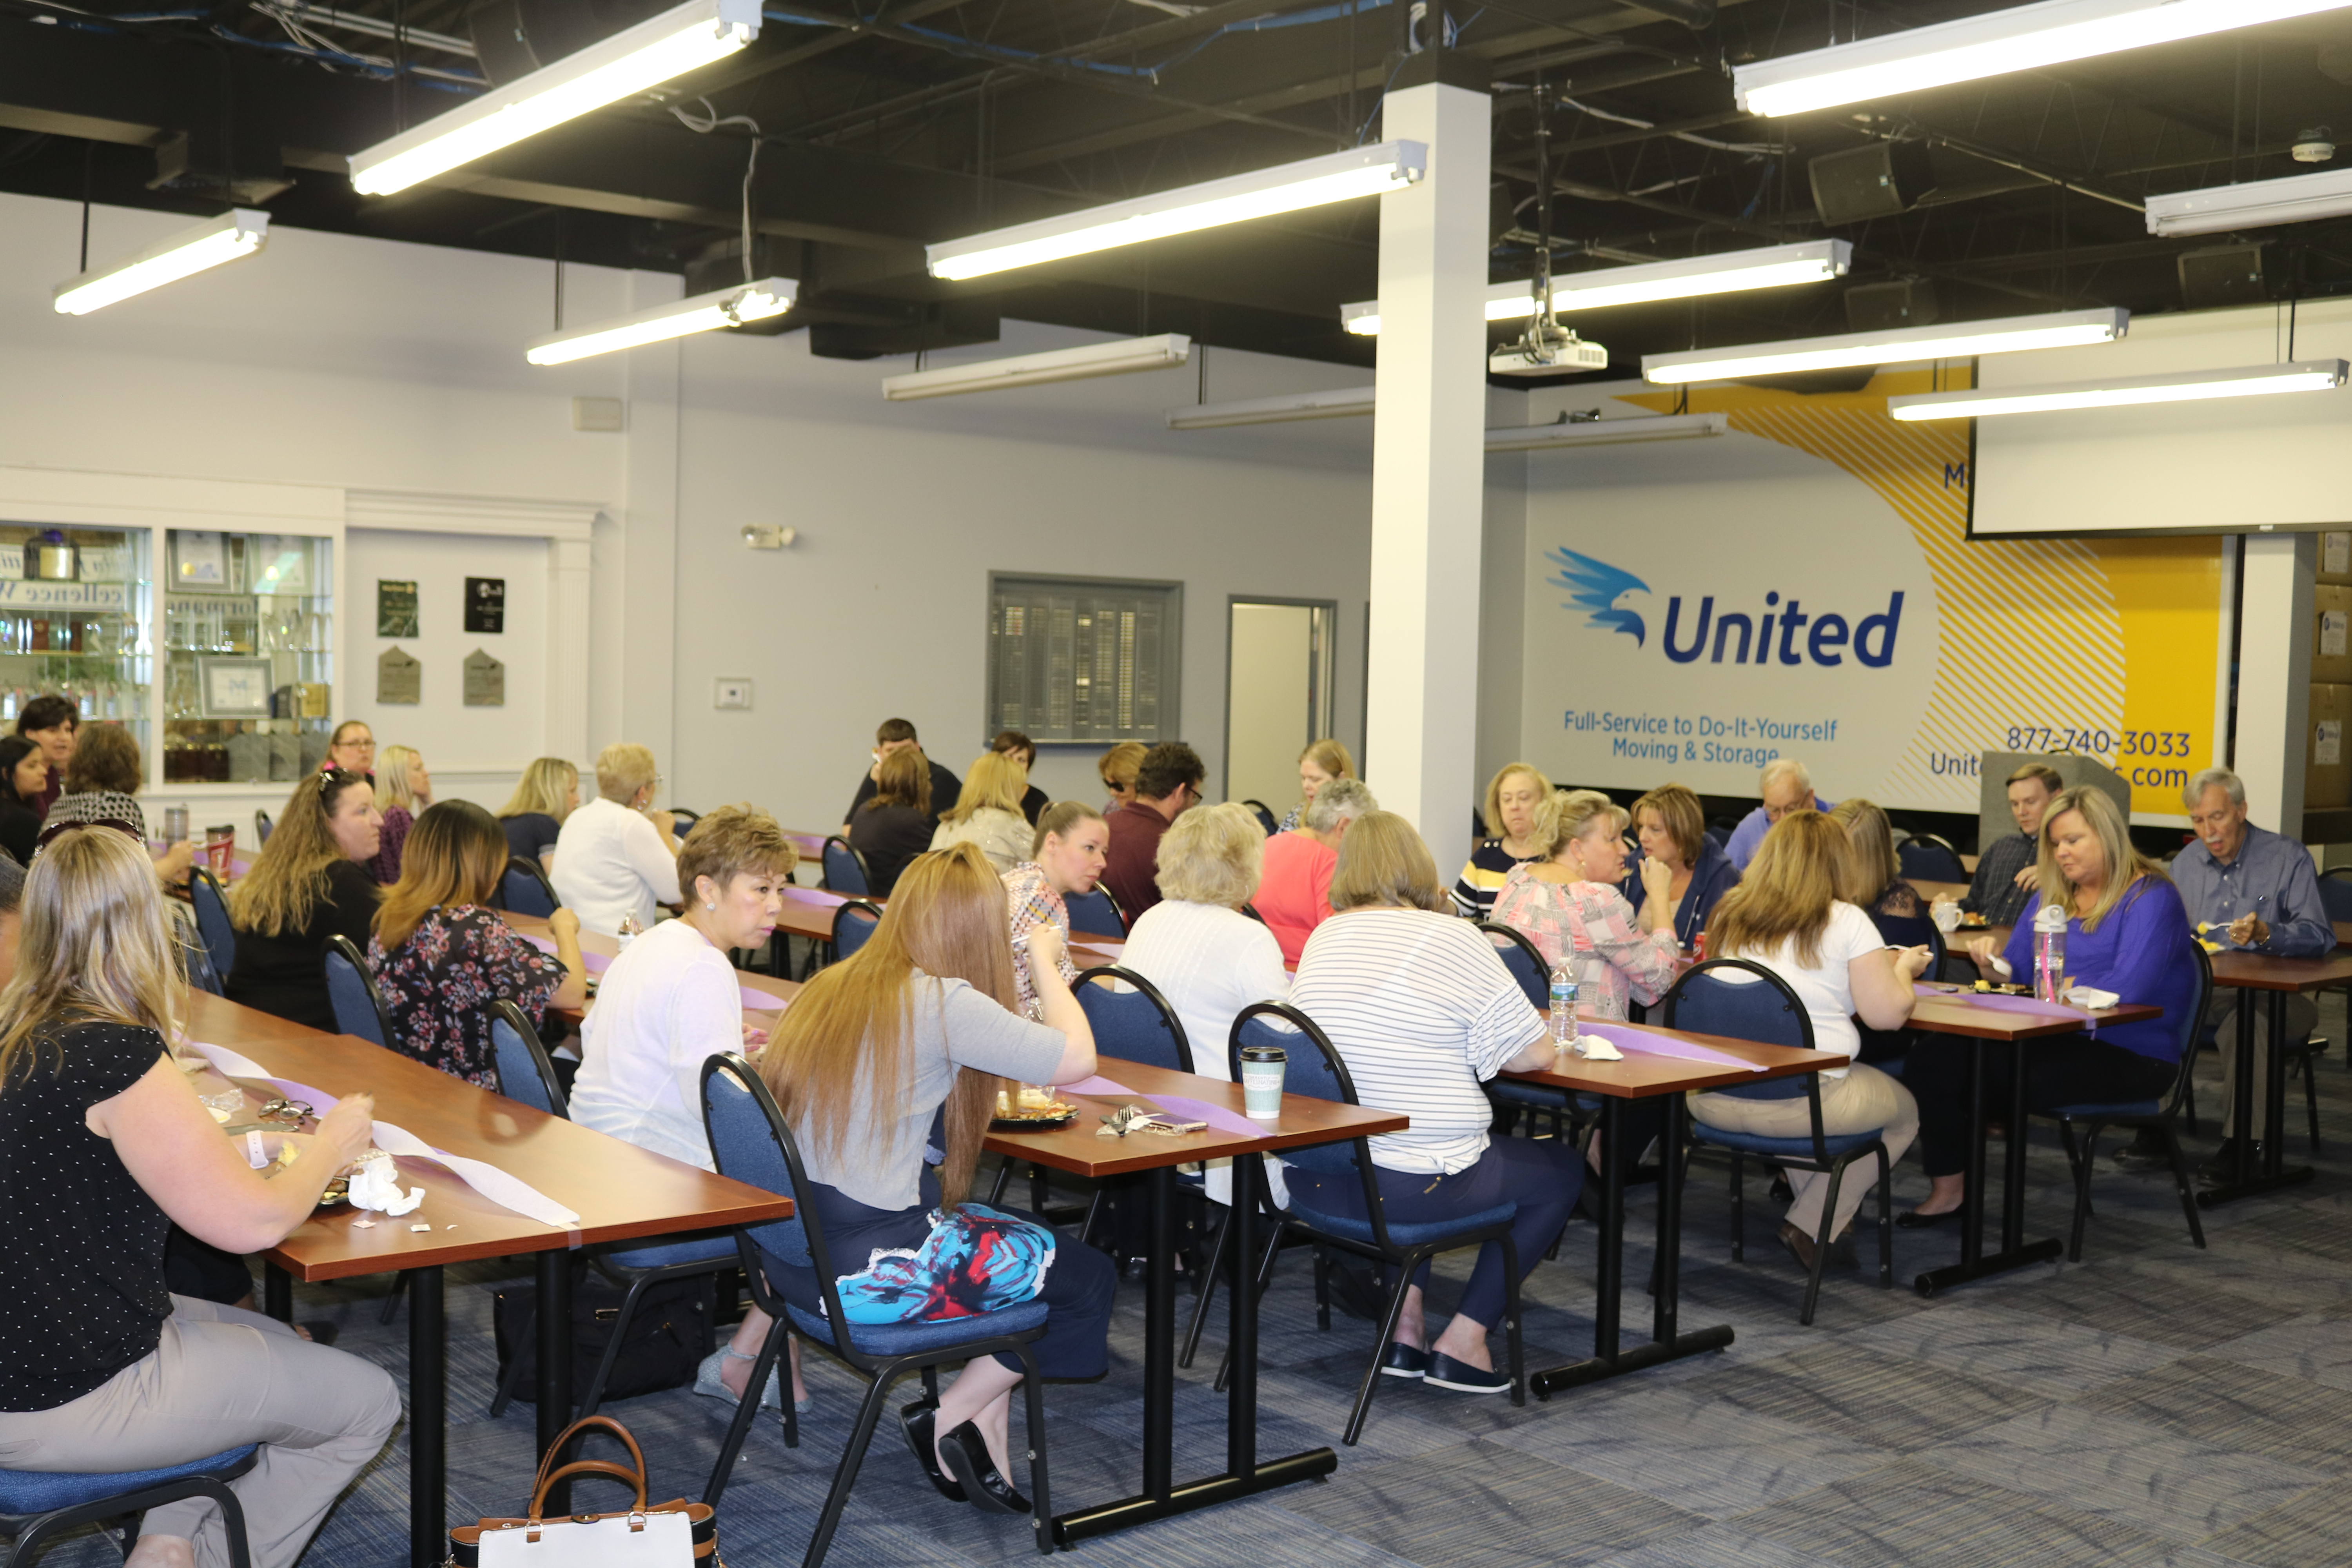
[188,992,793,1279]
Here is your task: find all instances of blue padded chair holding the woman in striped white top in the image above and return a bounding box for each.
[1216,1002,1526,1448]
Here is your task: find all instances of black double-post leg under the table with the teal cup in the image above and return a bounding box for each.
[1054,1154,1338,1549]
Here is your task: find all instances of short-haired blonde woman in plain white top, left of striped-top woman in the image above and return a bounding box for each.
[1120,804,1289,1203]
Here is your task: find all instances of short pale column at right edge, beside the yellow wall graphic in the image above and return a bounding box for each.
[2237,534,2319,839]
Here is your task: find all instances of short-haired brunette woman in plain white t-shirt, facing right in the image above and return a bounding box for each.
[572,804,809,1406]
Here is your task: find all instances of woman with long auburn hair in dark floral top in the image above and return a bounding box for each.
[367,804,588,1093]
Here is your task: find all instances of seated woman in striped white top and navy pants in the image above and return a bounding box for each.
[1284,818,1585,1394]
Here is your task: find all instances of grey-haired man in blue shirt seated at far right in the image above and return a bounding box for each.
[2173,769,2336,1171]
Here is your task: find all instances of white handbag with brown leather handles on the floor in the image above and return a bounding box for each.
[447,1415,727,1568]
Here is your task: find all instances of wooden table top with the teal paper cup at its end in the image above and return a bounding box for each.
[988,1056,1411,1176]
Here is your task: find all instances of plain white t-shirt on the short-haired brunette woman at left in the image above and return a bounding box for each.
[572,921,743,1171]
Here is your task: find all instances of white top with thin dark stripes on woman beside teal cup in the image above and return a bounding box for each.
[1291,907,1545,1176]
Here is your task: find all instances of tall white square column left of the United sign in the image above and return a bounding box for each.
[1364,49,1489,879]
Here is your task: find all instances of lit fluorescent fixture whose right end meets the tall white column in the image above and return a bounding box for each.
[924,144,1421,278]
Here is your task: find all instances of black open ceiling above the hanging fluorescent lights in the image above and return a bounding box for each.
[0,0,2352,374]
